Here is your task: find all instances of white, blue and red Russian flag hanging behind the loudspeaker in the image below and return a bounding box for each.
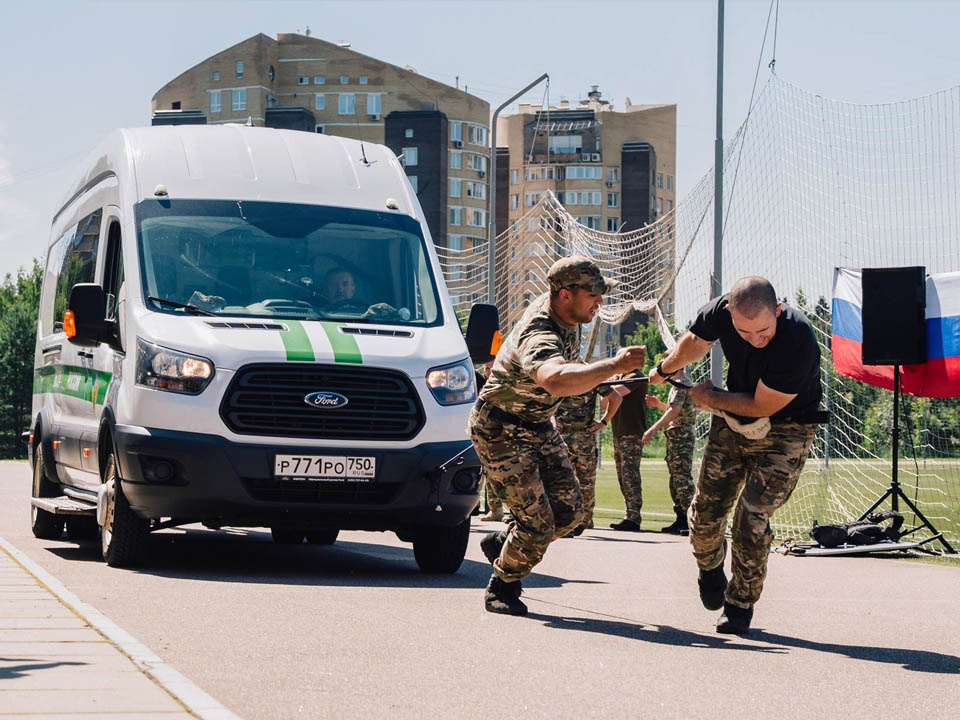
[831,268,960,397]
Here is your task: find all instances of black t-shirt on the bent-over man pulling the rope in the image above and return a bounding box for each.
[690,295,822,421]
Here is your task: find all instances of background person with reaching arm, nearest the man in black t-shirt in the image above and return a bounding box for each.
[643,371,697,535]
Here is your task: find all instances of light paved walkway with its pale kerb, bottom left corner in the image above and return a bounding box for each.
[0,538,236,720]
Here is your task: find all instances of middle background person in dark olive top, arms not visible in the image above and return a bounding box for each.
[610,371,647,532]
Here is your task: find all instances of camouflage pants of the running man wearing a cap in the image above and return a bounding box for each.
[469,405,583,582]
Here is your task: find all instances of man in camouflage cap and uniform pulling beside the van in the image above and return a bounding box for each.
[469,256,645,615]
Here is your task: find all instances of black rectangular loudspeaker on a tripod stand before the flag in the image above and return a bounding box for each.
[861,267,927,365]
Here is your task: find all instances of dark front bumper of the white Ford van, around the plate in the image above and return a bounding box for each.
[114,425,480,532]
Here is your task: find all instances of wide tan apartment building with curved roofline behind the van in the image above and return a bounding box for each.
[151,31,490,248]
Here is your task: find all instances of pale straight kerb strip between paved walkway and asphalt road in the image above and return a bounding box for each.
[0,536,241,720]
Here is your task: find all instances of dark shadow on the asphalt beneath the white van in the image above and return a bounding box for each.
[46,529,591,590]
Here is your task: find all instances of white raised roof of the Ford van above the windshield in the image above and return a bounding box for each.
[58,125,419,222]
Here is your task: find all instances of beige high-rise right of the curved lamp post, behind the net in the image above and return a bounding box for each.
[497,86,677,355]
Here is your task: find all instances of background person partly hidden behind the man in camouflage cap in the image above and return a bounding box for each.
[554,376,621,537]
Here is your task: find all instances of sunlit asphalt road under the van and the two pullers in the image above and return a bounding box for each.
[0,462,960,720]
